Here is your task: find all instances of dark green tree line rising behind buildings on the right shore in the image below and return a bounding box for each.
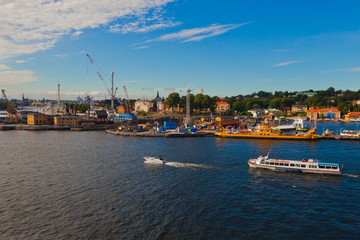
[166,87,360,115]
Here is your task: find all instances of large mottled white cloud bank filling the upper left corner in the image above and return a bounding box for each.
[0,0,174,59]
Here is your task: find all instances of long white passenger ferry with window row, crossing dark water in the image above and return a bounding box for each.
[248,154,341,175]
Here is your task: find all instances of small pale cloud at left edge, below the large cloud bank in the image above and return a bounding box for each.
[0,70,37,85]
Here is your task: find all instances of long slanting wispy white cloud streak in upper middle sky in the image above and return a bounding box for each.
[147,22,251,42]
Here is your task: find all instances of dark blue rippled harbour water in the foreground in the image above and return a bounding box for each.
[0,124,360,239]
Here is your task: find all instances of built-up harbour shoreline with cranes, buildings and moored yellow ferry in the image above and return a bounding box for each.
[0,84,360,140]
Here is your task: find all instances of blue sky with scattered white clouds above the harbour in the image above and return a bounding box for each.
[0,0,360,99]
